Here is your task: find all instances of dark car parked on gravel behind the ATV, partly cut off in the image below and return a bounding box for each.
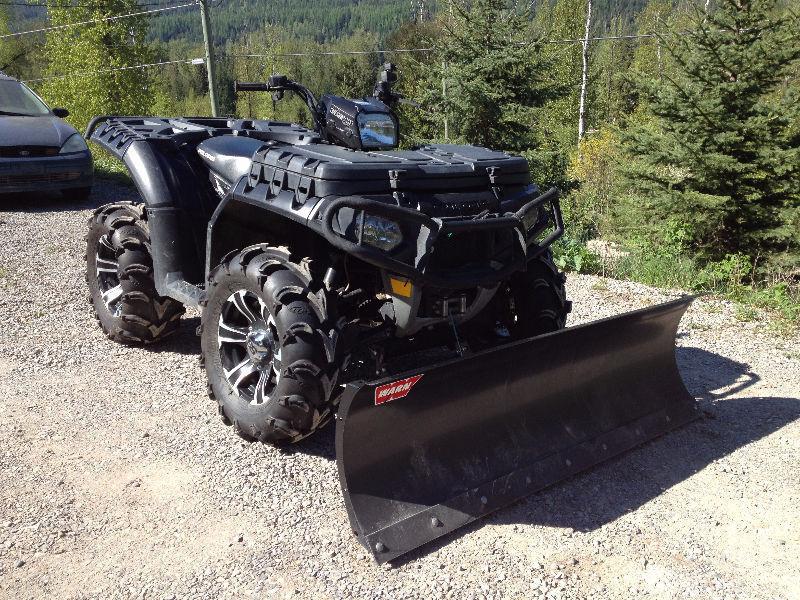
[0,72,94,200]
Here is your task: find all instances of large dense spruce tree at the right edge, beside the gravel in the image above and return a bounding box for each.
[619,0,800,268]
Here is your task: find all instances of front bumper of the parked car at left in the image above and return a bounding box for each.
[0,152,94,193]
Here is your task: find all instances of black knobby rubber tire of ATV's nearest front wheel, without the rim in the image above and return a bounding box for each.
[201,245,338,445]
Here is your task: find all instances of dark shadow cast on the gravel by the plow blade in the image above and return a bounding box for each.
[392,348,800,566]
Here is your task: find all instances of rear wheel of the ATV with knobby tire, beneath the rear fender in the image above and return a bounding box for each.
[86,202,184,344]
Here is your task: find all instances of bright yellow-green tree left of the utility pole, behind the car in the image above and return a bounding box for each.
[41,0,153,127]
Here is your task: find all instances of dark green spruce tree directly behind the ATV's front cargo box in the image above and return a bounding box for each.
[422,0,554,151]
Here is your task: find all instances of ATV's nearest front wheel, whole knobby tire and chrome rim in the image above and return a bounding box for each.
[201,245,337,444]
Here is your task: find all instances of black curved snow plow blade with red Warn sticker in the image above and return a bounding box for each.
[336,298,697,563]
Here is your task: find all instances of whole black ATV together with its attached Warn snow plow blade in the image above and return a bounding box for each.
[87,65,694,562]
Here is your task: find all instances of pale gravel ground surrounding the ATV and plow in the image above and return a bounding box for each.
[0,182,800,599]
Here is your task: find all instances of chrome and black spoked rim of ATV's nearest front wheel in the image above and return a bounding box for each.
[217,290,281,404]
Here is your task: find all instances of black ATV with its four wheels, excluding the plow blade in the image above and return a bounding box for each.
[87,65,569,442]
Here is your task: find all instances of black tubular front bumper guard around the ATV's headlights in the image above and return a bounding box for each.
[322,188,564,289]
